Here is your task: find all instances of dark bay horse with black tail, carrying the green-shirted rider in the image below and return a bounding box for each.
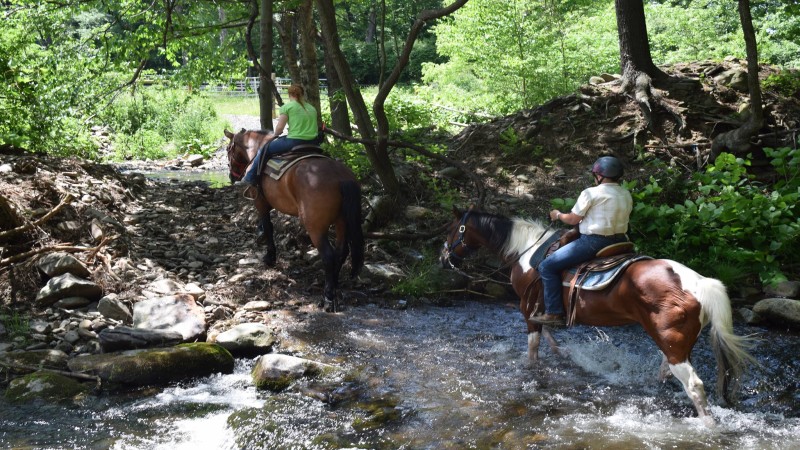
[225,129,364,311]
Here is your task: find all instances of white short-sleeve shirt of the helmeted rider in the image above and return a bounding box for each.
[572,183,633,236]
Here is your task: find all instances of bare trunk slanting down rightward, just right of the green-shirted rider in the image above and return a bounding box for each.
[315,0,400,198]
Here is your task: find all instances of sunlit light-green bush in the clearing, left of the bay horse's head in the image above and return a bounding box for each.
[100,87,225,159]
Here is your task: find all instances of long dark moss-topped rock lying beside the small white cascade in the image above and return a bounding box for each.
[69,342,234,389]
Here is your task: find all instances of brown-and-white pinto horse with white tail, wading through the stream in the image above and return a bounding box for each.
[441,208,755,425]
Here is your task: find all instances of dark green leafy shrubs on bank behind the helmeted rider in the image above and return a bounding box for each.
[631,148,800,283]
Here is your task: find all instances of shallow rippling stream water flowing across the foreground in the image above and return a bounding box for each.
[0,302,800,450]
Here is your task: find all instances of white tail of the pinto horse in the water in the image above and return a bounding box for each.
[694,277,758,403]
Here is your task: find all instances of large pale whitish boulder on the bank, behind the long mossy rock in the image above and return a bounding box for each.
[133,294,206,341]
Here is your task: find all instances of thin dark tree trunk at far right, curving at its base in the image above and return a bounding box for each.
[709,0,764,161]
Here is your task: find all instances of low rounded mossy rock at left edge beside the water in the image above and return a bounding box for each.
[5,372,90,403]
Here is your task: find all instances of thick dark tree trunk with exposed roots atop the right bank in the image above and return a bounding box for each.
[614,0,682,129]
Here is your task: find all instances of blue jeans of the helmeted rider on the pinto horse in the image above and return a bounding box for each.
[537,234,627,314]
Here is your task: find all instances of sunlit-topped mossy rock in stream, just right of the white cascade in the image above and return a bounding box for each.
[252,353,332,392]
